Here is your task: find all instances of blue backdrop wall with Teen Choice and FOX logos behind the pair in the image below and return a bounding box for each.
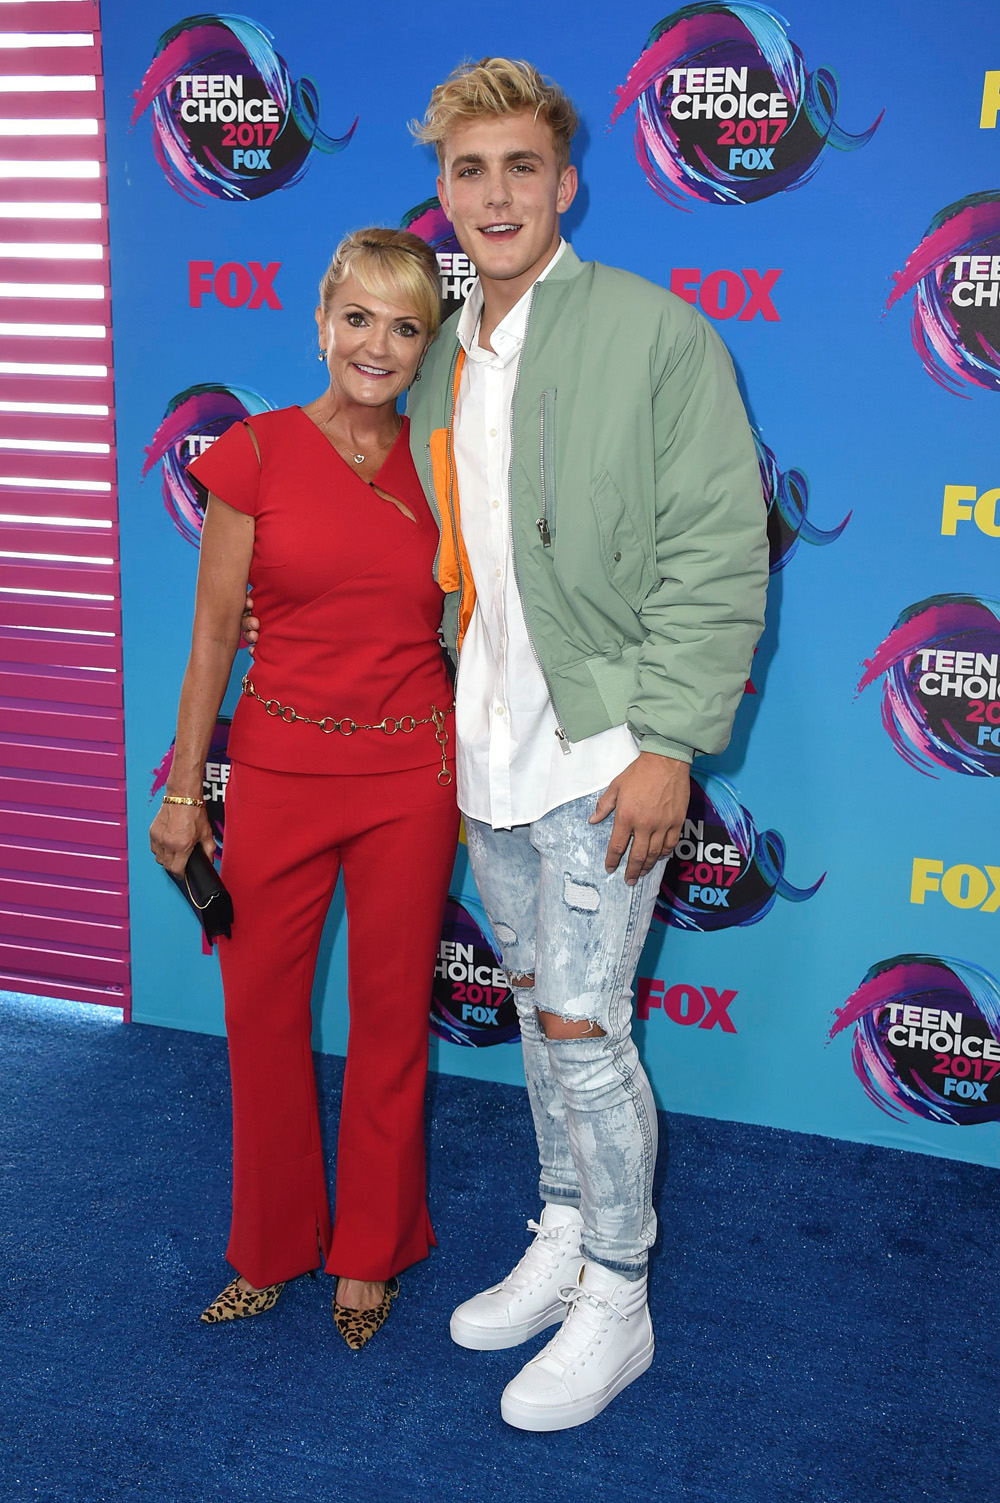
[104,0,1000,1165]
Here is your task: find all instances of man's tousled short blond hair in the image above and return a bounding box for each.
[411,57,577,173]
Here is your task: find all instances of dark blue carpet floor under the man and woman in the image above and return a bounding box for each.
[0,996,1000,1503]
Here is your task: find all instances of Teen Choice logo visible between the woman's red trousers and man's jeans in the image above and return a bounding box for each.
[430,897,520,1049]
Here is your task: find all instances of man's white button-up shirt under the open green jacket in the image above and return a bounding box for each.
[454,240,638,830]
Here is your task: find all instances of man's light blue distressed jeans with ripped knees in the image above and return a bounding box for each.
[466,794,666,1279]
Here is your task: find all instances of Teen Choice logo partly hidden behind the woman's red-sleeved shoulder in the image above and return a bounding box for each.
[143,382,271,547]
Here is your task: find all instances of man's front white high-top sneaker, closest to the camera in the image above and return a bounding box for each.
[501,1261,653,1429]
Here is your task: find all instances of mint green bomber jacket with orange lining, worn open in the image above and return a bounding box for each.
[408,246,768,761]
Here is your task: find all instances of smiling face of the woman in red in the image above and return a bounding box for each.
[316,275,427,407]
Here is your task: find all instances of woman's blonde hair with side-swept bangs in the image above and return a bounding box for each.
[319,227,441,340]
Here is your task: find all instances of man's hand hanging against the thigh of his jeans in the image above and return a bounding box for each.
[589,752,690,887]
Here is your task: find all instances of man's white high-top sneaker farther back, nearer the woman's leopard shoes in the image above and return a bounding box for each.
[451,1204,583,1351]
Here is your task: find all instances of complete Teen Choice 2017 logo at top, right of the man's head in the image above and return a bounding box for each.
[611,0,884,209]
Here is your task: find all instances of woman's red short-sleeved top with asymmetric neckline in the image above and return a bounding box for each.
[188,407,454,773]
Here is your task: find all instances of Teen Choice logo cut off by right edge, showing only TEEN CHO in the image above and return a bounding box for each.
[886,191,1000,397]
